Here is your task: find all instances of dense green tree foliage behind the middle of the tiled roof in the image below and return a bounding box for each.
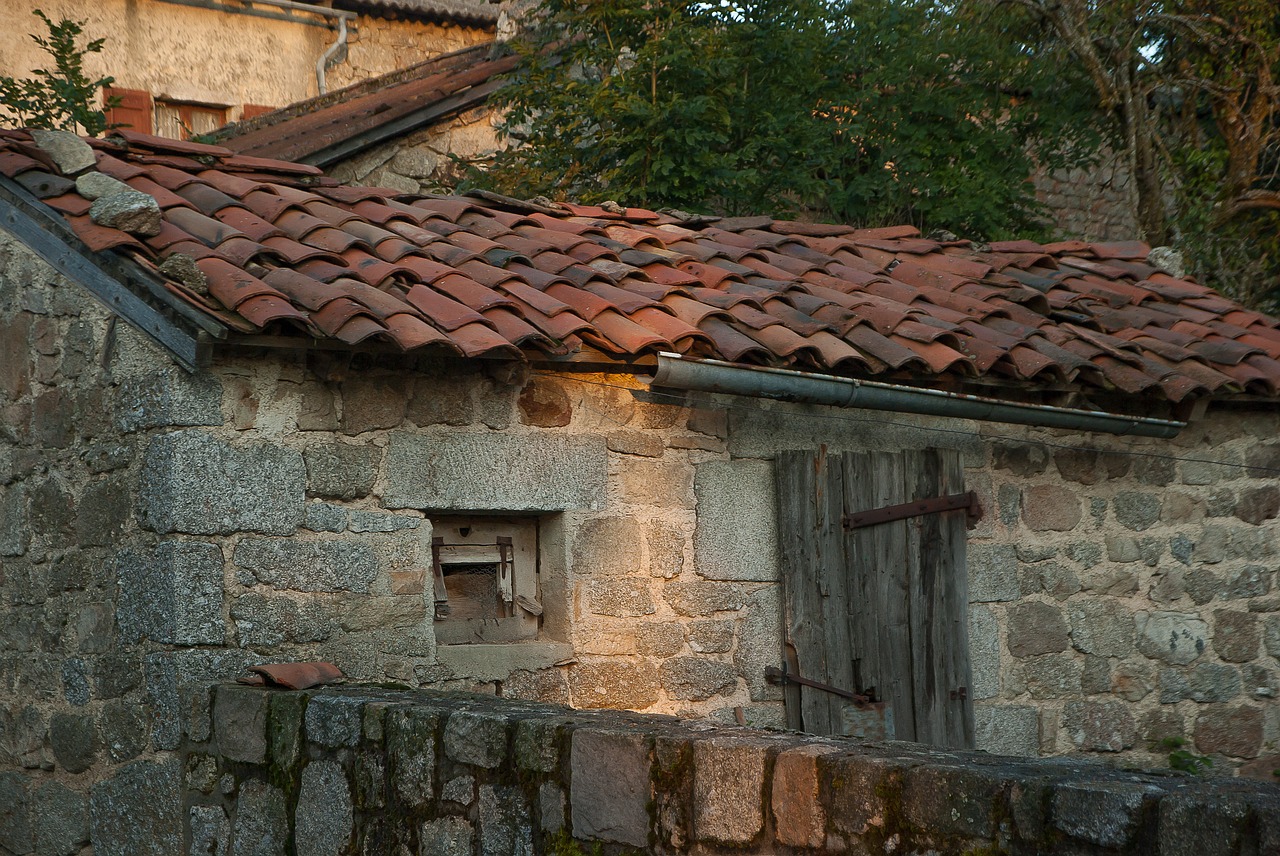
[480,0,1097,237]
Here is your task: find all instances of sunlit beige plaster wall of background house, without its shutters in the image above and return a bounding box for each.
[0,0,489,122]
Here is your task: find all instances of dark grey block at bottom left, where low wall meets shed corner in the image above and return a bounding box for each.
[90,757,183,856]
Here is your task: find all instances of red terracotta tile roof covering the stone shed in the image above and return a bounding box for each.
[0,134,1280,402]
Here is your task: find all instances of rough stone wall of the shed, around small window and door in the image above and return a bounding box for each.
[0,220,1280,852]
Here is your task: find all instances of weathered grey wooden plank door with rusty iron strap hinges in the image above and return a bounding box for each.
[777,449,973,747]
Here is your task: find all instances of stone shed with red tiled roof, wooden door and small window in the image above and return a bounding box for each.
[0,131,1280,852]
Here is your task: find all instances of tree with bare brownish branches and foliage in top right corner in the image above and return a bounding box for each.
[993,0,1280,311]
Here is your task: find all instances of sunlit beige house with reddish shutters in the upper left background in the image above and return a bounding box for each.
[0,0,498,138]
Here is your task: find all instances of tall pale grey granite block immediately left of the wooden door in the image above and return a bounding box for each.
[694,459,778,582]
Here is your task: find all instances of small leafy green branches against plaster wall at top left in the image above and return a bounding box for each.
[0,9,114,137]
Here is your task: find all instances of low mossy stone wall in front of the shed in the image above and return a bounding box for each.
[35,685,1280,856]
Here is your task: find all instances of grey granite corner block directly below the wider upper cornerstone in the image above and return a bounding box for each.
[115,541,227,645]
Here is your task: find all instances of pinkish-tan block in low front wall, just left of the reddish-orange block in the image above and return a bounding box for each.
[694,738,768,846]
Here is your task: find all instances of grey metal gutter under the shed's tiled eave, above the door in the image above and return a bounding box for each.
[649,353,1187,438]
